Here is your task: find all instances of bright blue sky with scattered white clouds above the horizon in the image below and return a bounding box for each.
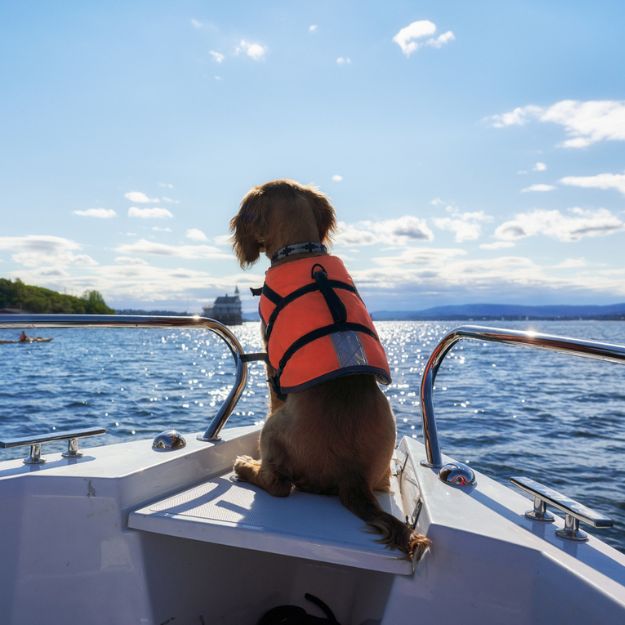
[0,0,625,313]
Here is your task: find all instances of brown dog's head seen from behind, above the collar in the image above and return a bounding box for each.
[230,180,336,267]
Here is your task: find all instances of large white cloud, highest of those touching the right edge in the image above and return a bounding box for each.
[489,100,625,148]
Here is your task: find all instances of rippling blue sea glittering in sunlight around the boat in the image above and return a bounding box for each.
[0,320,625,553]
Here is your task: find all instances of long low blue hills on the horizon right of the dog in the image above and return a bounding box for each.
[372,303,625,321]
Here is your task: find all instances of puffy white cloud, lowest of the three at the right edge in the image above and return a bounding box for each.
[495,208,625,242]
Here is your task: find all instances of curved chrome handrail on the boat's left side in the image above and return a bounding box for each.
[0,314,264,441]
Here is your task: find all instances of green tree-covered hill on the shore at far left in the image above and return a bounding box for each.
[0,278,115,315]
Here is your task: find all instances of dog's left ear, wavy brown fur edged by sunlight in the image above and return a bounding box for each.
[230,188,266,268]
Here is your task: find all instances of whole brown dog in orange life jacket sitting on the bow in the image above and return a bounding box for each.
[230,180,430,558]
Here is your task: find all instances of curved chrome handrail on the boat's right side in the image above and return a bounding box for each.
[421,326,625,469]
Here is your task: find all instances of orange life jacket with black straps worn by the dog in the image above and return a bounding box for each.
[258,255,391,395]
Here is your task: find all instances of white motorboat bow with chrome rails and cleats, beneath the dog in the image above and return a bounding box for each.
[0,315,625,625]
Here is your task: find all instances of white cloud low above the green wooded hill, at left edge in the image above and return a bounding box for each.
[0,234,97,269]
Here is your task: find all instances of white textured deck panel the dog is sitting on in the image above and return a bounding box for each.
[128,473,413,575]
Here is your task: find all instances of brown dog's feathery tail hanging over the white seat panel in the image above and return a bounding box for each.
[339,473,430,560]
